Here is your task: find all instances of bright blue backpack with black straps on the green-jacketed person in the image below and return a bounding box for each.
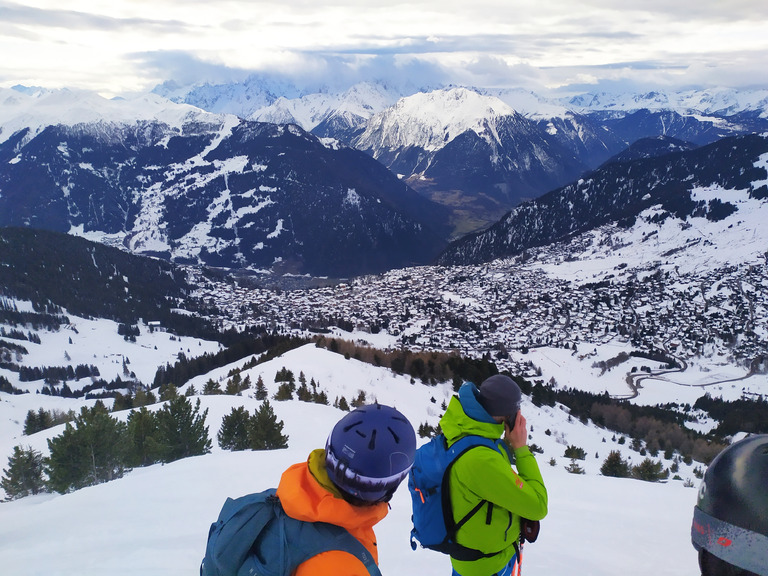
[408,434,505,561]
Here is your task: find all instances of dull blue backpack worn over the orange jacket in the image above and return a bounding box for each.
[200,488,381,576]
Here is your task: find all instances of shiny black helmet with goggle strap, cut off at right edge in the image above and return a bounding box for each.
[691,434,768,576]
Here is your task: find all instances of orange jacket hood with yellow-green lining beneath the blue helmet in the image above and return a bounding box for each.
[277,449,389,535]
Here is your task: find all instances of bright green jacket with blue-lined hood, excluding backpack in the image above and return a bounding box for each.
[440,382,547,576]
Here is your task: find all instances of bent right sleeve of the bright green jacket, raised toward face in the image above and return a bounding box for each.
[454,446,548,520]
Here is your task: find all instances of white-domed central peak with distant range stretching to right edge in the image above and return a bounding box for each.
[238,84,768,232]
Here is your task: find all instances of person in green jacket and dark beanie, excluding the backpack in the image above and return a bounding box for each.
[440,374,547,576]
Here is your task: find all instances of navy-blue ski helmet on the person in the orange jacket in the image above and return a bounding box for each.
[325,404,416,503]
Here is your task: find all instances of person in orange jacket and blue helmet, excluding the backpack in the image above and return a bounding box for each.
[277,404,416,576]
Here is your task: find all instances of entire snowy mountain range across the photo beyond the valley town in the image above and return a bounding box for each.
[0,79,768,276]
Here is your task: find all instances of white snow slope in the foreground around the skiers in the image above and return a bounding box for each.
[0,346,698,576]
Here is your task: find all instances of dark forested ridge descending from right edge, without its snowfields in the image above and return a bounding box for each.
[438,135,768,265]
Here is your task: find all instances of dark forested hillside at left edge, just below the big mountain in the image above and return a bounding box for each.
[0,228,213,337]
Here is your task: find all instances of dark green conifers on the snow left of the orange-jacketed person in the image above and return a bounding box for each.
[0,388,288,500]
